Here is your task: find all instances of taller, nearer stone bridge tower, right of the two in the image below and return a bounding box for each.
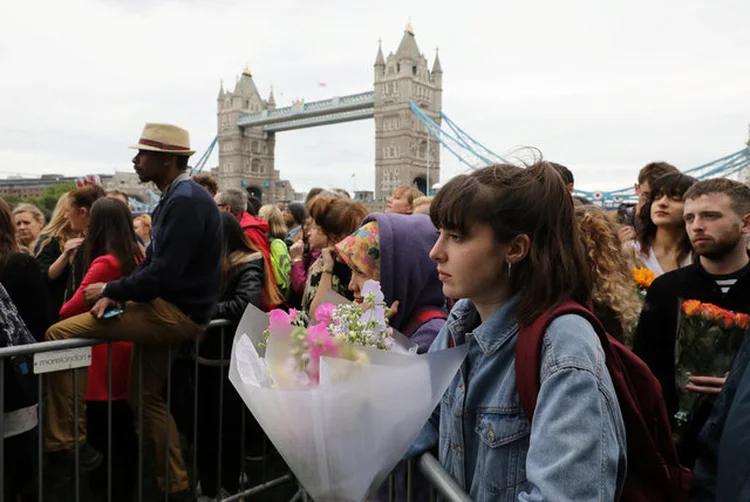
[374,24,443,200]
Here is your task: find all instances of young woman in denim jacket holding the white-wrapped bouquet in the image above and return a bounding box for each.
[408,162,626,502]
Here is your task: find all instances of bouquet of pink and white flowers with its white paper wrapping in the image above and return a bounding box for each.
[229,283,467,502]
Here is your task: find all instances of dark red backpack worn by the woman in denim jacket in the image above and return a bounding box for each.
[515,301,691,502]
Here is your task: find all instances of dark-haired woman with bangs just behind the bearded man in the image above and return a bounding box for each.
[625,173,698,277]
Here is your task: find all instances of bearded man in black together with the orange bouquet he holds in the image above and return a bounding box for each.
[633,178,750,467]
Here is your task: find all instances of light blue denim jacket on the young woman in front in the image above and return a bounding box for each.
[407,297,626,502]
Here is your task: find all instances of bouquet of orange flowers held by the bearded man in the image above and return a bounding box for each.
[675,300,750,434]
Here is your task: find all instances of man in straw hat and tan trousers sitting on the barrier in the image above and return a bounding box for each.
[44,124,222,500]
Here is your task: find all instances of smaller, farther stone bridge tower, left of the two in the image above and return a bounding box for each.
[216,68,293,202]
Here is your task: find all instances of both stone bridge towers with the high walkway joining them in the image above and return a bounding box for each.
[216,25,443,202]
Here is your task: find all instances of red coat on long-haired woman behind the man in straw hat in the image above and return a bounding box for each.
[60,254,133,401]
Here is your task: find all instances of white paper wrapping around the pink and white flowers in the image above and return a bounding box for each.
[229,306,466,502]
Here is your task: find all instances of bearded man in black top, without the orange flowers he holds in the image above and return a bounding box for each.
[633,178,750,467]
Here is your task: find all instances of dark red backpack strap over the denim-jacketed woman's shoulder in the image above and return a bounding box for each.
[515,301,609,421]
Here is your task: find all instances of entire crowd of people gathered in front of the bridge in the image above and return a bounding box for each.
[0,124,750,501]
